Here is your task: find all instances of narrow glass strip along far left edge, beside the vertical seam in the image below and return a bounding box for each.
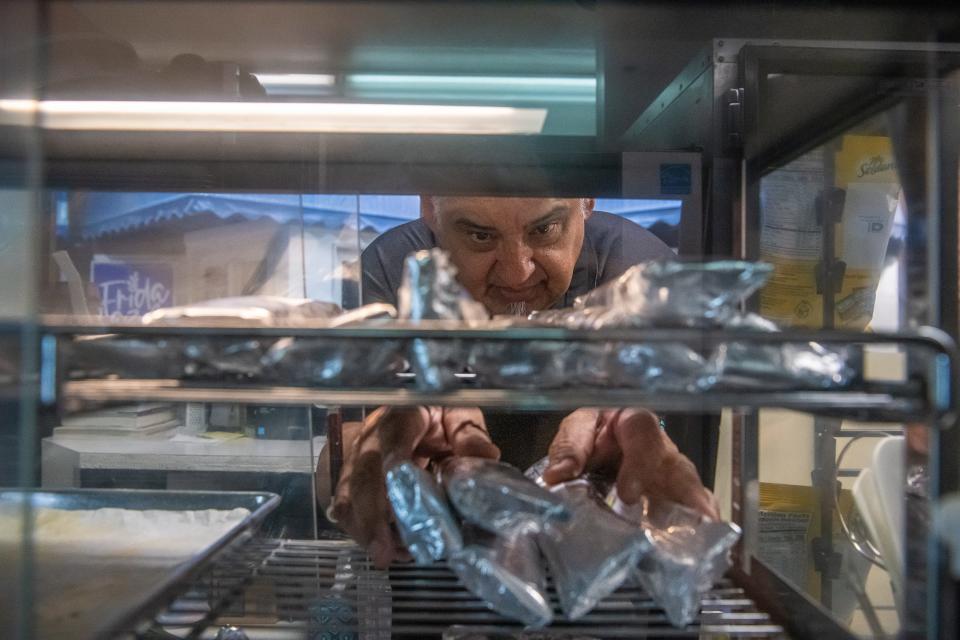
[0,2,42,640]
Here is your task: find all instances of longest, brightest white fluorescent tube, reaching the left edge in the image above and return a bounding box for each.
[0,100,547,135]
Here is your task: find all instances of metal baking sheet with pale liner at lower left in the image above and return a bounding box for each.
[0,489,280,640]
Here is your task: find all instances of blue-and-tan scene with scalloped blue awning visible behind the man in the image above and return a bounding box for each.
[42,191,681,318]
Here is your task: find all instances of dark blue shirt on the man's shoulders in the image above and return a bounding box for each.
[360,211,675,307]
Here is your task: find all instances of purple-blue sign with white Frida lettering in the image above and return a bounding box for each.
[90,262,173,317]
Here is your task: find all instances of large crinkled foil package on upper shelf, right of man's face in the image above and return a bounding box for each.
[573,260,773,328]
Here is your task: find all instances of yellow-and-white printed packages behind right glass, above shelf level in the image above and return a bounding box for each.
[760,136,900,330]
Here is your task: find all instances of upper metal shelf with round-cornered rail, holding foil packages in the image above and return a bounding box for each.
[43,321,955,422]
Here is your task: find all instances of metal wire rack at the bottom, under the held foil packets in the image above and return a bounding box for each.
[142,540,785,640]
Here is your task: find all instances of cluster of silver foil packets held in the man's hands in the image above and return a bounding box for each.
[387,458,739,628]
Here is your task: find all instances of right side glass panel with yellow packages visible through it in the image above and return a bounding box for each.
[758,84,936,636]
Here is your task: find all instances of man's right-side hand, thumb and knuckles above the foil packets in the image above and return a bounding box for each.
[543,409,719,519]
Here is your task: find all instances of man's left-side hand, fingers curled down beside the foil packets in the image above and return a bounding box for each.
[331,407,500,568]
